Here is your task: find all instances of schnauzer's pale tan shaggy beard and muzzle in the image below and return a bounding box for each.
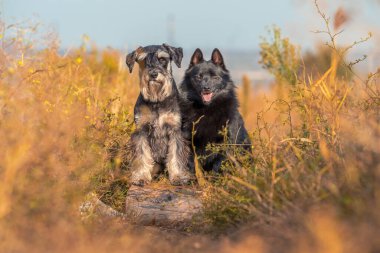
[140,71,173,102]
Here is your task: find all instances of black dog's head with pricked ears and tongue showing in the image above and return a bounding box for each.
[182,48,235,106]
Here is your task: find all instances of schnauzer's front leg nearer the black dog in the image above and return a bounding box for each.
[166,130,190,185]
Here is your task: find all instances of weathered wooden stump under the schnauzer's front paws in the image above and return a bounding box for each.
[126,185,202,227]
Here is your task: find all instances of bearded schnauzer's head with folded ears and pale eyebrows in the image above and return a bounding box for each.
[126,44,183,102]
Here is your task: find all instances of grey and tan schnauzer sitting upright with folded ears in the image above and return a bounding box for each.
[126,44,190,185]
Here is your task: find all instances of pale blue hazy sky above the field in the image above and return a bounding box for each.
[0,0,380,50]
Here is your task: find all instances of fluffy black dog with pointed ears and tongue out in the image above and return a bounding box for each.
[180,48,251,172]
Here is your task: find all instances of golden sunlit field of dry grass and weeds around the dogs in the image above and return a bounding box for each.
[0,2,380,253]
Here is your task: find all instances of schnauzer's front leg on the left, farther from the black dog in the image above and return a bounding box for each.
[131,131,155,185]
